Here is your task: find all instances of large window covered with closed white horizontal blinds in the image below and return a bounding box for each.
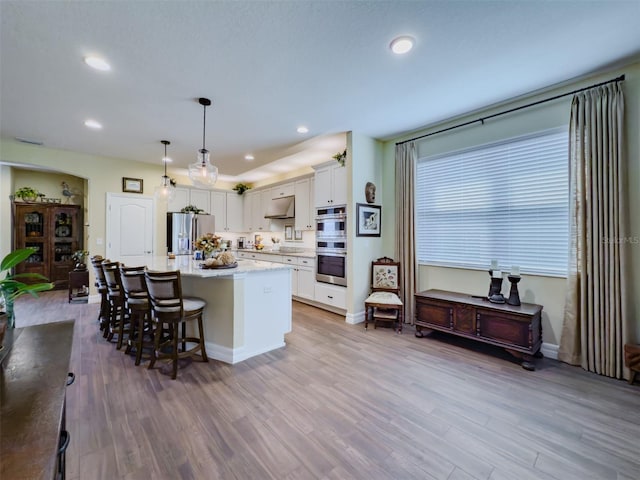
[416,129,569,276]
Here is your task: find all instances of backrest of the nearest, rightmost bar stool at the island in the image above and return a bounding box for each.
[144,270,184,321]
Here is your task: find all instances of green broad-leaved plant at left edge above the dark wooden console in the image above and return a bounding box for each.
[0,248,53,328]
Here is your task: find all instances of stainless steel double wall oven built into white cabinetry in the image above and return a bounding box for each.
[316,205,347,287]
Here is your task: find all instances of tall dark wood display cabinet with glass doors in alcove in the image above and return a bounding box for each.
[13,202,83,289]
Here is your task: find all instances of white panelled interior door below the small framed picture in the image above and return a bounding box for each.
[106,193,155,266]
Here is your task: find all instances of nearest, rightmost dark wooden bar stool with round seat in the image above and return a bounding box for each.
[145,270,209,379]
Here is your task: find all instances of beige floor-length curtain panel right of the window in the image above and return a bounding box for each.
[558,82,629,378]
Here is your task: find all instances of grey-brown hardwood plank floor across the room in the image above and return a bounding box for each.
[11,292,640,480]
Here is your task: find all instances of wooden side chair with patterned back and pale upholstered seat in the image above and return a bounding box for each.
[364,257,403,333]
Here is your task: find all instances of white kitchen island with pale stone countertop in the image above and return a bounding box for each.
[147,255,291,364]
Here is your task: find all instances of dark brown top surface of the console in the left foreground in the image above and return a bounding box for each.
[0,320,74,480]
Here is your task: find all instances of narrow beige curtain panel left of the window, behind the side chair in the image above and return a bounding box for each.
[396,142,417,324]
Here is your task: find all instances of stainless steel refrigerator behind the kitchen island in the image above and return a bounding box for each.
[167,212,216,255]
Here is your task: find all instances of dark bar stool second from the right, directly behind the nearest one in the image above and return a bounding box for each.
[120,265,153,365]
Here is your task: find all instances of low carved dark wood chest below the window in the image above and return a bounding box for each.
[415,290,542,370]
